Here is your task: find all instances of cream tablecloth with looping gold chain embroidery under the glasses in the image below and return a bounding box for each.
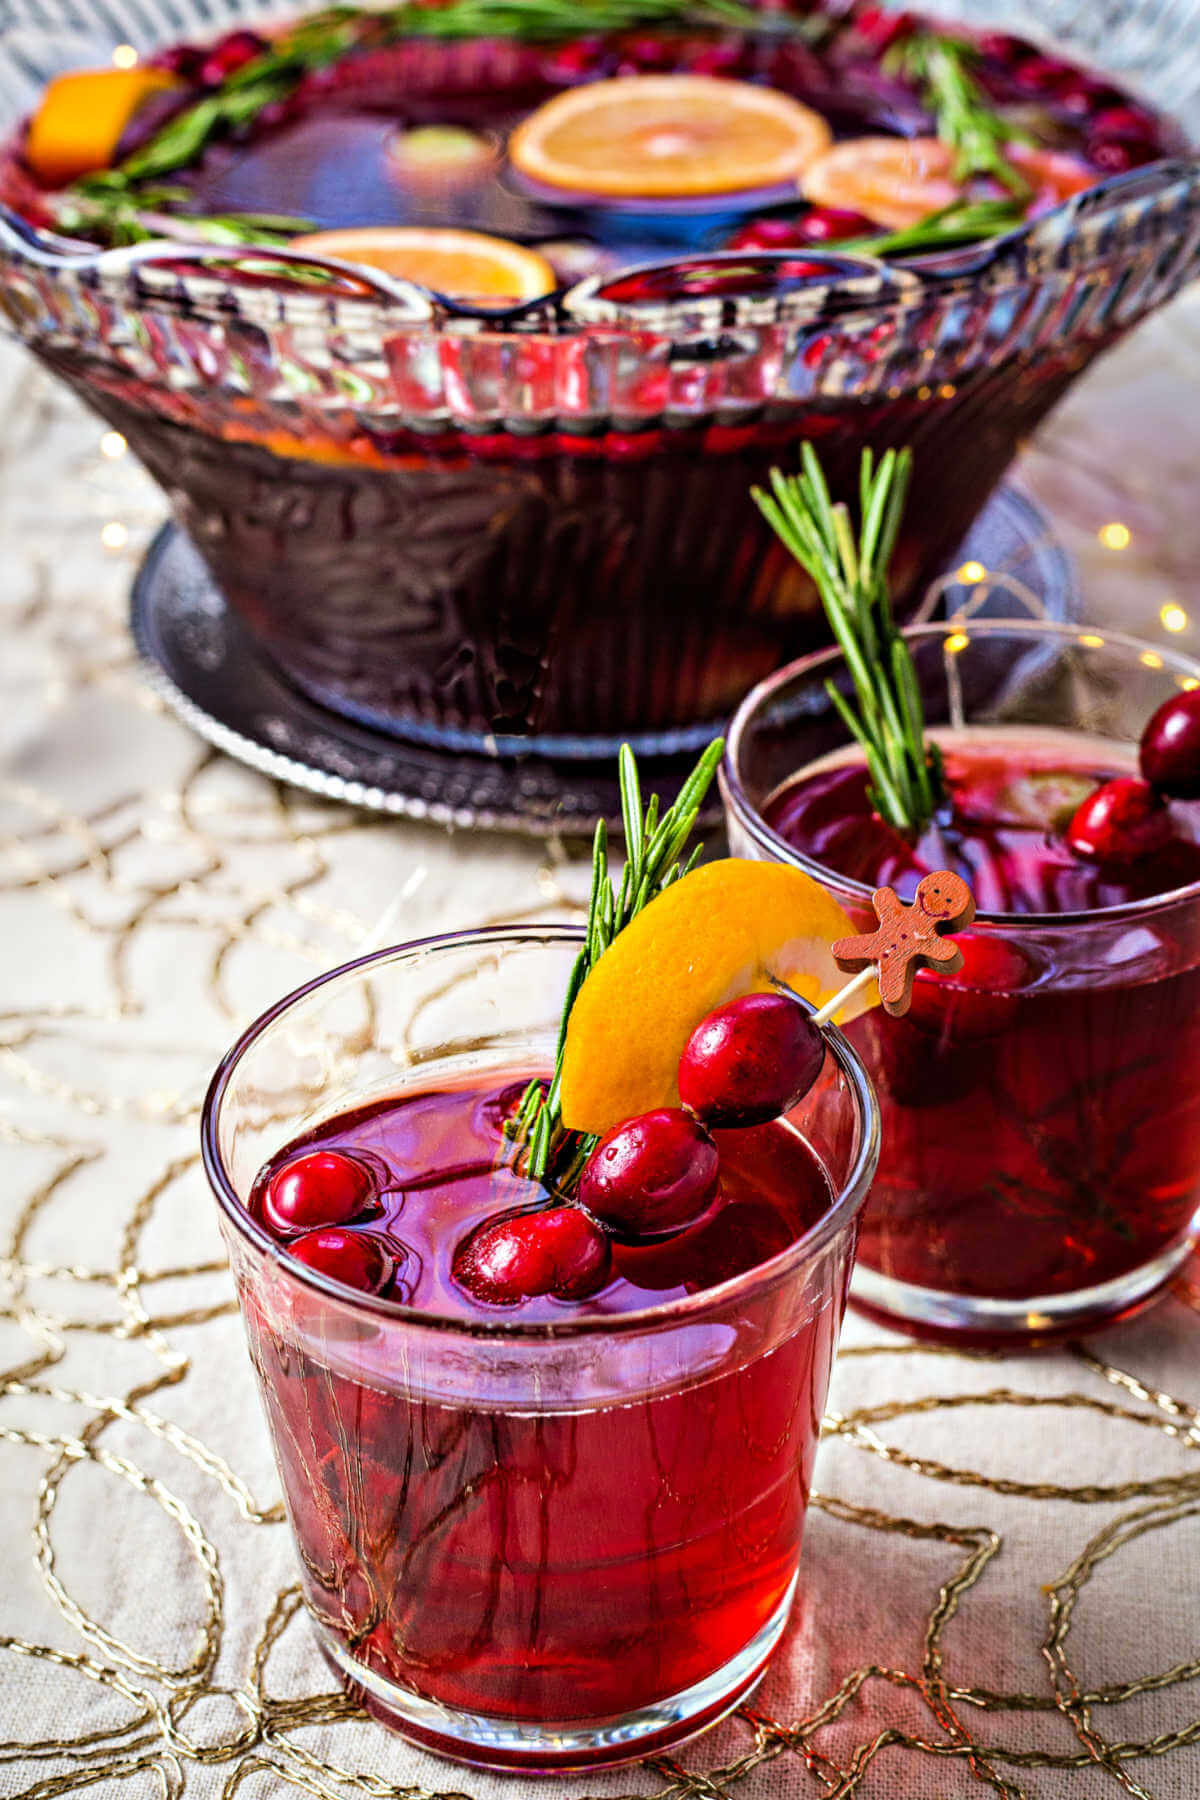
[0,284,1200,1800]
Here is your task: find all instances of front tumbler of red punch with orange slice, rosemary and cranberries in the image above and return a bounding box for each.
[203,745,878,1769]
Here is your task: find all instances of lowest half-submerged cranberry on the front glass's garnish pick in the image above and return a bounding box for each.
[453,1206,612,1307]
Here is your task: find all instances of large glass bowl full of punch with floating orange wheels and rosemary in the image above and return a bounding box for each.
[0,0,1196,760]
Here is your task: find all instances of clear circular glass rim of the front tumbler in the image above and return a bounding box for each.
[200,923,880,1345]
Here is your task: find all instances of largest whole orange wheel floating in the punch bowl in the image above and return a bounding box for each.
[509,76,833,200]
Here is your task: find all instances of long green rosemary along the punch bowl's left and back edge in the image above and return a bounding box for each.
[58,0,817,245]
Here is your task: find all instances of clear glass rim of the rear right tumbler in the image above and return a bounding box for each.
[718,619,1200,931]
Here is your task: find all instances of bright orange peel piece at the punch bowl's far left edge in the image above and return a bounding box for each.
[25,67,184,187]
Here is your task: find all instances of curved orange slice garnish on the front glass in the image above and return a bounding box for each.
[561,857,878,1134]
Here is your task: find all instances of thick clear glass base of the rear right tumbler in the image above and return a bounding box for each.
[849,1217,1200,1350]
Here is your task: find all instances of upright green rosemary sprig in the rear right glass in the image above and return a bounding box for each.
[752,443,943,833]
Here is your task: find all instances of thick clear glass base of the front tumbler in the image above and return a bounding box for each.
[313,1577,797,1773]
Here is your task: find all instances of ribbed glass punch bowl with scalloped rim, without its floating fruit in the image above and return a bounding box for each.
[0,0,1200,758]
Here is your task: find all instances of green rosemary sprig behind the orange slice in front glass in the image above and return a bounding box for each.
[509,738,725,1193]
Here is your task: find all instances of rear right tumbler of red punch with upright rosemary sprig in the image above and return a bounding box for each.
[725,439,1200,1343]
